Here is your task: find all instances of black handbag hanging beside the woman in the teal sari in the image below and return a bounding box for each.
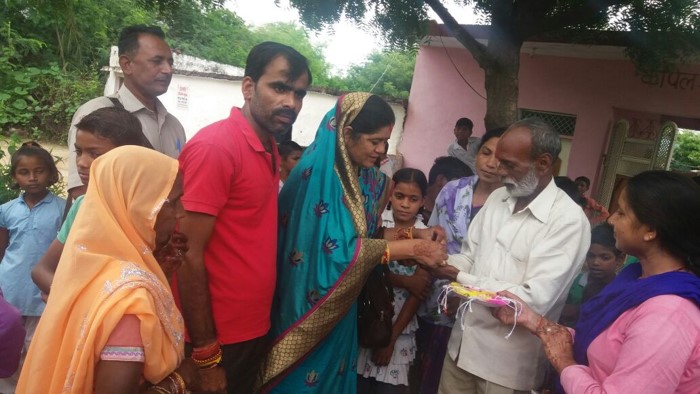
[357,264,394,349]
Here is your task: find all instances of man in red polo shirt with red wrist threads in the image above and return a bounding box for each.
[177,42,311,393]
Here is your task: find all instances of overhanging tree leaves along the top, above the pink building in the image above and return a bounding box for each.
[290,0,700,67]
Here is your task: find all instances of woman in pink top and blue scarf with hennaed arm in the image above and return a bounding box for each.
[494,171,700,394]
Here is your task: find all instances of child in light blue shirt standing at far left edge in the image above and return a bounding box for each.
[0,143,65,392]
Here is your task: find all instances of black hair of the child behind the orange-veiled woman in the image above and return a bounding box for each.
[75,107,153,149]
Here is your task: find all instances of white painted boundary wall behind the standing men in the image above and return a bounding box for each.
[105,47,406,154]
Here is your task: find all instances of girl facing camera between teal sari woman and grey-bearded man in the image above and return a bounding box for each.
[357,168,428,394]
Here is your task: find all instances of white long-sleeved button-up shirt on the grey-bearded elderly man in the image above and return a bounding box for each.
[448,180,591,390]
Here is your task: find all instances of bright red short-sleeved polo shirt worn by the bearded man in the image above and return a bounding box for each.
[179,107,280,344]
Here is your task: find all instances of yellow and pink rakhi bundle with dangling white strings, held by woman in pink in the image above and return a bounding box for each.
[438,282,523,339]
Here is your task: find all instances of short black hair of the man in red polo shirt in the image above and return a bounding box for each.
[243,41,313,85]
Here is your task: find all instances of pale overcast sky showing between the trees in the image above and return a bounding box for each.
[226,0,476,72]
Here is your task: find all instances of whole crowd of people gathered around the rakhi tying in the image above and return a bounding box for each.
[0,26,700,394]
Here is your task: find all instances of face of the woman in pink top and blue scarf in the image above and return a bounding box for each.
[608,189,656,256]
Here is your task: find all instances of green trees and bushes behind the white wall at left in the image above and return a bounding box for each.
[0,0,415,142]
